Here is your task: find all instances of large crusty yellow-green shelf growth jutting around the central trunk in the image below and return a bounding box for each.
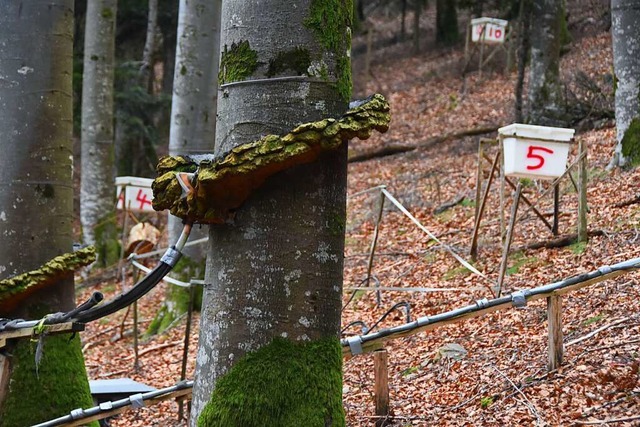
[152,94,390,224]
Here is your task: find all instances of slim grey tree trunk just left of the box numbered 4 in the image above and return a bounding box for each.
[80,0,117,246]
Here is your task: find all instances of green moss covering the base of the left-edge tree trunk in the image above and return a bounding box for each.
[0,334,98,427]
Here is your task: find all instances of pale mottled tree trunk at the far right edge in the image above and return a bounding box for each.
[609,0,640,169]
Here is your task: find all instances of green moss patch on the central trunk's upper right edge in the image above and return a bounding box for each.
[304,0,353,101]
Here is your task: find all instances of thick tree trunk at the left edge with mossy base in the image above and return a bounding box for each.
[0,0,97,427]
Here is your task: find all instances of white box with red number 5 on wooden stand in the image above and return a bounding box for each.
[498,123,575,179]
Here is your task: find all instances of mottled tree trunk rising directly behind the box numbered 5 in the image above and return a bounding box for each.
[528,0,566,126]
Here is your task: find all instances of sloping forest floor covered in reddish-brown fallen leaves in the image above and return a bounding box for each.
[78,4,640,426]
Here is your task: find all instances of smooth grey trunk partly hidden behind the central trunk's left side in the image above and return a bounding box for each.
[148,0,222,333]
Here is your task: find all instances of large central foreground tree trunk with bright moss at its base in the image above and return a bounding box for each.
[191,0,352,426]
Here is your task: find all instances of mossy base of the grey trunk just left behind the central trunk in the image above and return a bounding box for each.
[145,256,206,337]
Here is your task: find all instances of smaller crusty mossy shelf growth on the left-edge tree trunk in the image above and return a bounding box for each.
[0,246,96,313]
